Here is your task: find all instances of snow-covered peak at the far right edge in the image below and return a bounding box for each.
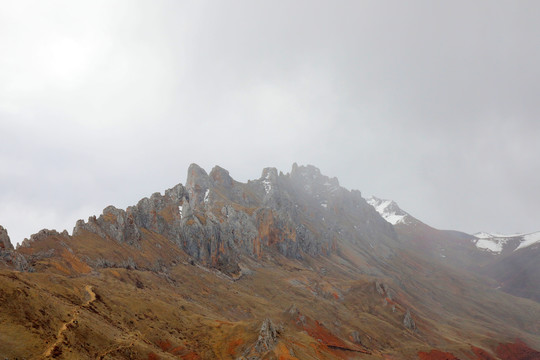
[472,232,540,255]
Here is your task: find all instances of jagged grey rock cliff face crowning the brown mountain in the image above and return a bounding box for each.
[64,164,396,272]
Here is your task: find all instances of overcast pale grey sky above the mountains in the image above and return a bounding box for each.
[0,0,540,242]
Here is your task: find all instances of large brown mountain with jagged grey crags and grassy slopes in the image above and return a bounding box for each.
[0,164,540,360]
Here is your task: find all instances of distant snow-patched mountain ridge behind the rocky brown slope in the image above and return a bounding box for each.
[367,197,540,302]
